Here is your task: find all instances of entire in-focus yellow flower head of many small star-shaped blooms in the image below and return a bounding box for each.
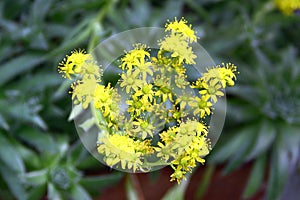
[59,18,236,183]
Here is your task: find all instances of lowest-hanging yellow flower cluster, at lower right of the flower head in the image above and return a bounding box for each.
[155,120,210,183]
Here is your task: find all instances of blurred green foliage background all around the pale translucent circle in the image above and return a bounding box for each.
[0,0,300,200]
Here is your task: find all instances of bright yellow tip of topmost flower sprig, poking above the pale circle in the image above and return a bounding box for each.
[165,17,197,43]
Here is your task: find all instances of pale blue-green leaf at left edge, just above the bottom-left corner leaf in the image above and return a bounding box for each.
[0,132,25,172]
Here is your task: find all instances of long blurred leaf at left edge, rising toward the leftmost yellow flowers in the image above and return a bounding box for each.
[0,54,44,86]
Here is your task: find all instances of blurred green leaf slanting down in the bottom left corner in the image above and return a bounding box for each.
[0,162,27,200]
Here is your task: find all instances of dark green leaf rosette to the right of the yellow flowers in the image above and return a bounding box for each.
[210,48,300,199]
